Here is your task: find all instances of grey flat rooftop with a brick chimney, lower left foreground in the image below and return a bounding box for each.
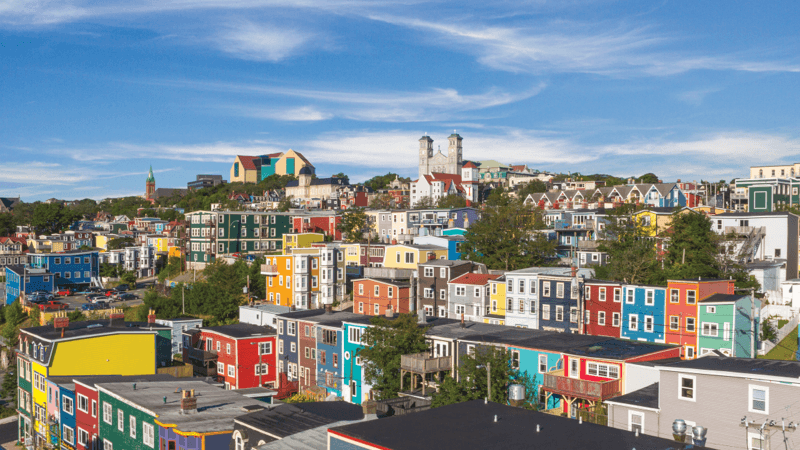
[97,378,265,433]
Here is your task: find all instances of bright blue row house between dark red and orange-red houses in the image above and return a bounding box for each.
[620,285,667,343]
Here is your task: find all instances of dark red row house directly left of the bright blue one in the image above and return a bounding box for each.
[583,280,622,338]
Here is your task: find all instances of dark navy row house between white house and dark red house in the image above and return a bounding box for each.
[538,274,583,333]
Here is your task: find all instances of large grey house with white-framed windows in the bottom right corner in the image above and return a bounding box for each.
[605,356,800,450]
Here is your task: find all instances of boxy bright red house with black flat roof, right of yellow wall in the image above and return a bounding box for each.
[183,323,278,389]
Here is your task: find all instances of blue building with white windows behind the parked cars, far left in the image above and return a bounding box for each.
[29,250,100,287]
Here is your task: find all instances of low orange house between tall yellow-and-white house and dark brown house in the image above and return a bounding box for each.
[353,278,414,316]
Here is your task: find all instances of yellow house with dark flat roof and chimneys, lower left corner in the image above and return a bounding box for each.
[17,317,162,442]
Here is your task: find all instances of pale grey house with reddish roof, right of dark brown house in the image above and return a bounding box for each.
[445,273,500,322]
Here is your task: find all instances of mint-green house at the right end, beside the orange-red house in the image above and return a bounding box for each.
[697,294,759,358]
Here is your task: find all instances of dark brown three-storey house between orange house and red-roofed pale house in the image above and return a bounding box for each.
[413,259,486,317]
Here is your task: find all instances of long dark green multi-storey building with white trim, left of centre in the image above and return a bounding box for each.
[186,211,292,269]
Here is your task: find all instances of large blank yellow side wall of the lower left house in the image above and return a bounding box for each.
[48,333,156,376]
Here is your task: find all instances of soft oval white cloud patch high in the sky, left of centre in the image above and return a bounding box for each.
[210,21,314,62]
